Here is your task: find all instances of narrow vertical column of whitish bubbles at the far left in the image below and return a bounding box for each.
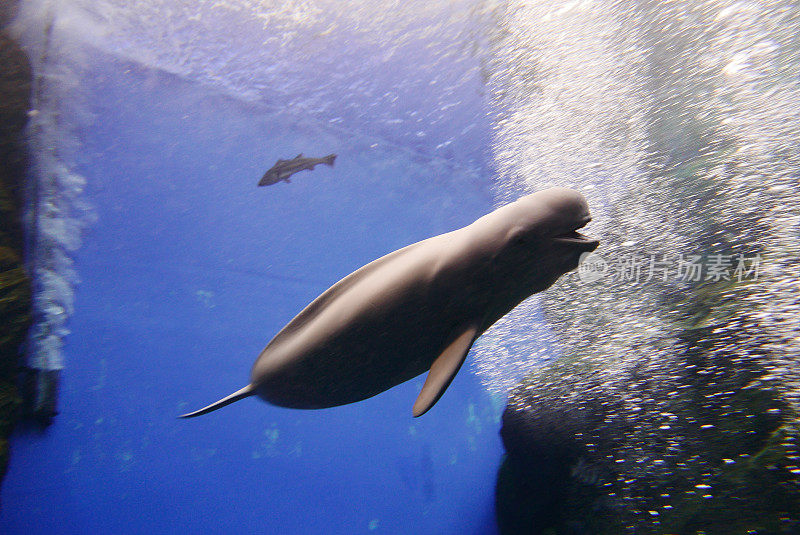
[14,1,92,370]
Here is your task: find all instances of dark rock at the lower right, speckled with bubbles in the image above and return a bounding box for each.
[497,328,800,535]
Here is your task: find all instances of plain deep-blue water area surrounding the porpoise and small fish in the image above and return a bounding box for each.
[0,59,502,535]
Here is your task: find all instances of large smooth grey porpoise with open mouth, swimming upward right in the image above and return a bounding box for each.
[183,188,598,417]
